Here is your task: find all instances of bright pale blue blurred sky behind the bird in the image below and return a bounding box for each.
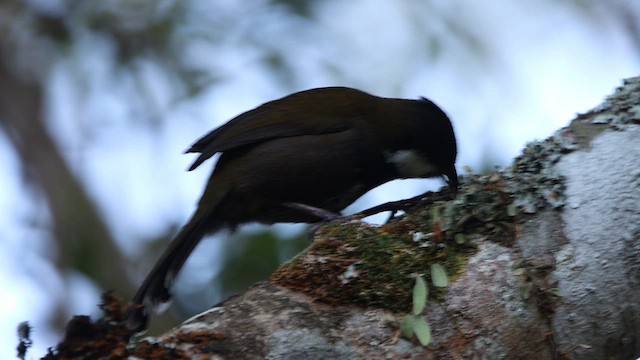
[0,0,640,358]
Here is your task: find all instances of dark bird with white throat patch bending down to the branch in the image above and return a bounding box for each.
[127,87,458,331]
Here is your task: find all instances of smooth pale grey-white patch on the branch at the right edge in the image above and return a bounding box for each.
[554,124,640,359]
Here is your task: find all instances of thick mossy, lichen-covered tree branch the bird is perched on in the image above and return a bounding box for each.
[43,78,640,359]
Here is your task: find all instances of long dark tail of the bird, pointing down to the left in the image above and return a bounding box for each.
[127,212,224,331]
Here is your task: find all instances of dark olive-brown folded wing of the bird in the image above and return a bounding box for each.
[187,89,369,170]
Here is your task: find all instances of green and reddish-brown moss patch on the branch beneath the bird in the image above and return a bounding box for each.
[273,222,465,311]
